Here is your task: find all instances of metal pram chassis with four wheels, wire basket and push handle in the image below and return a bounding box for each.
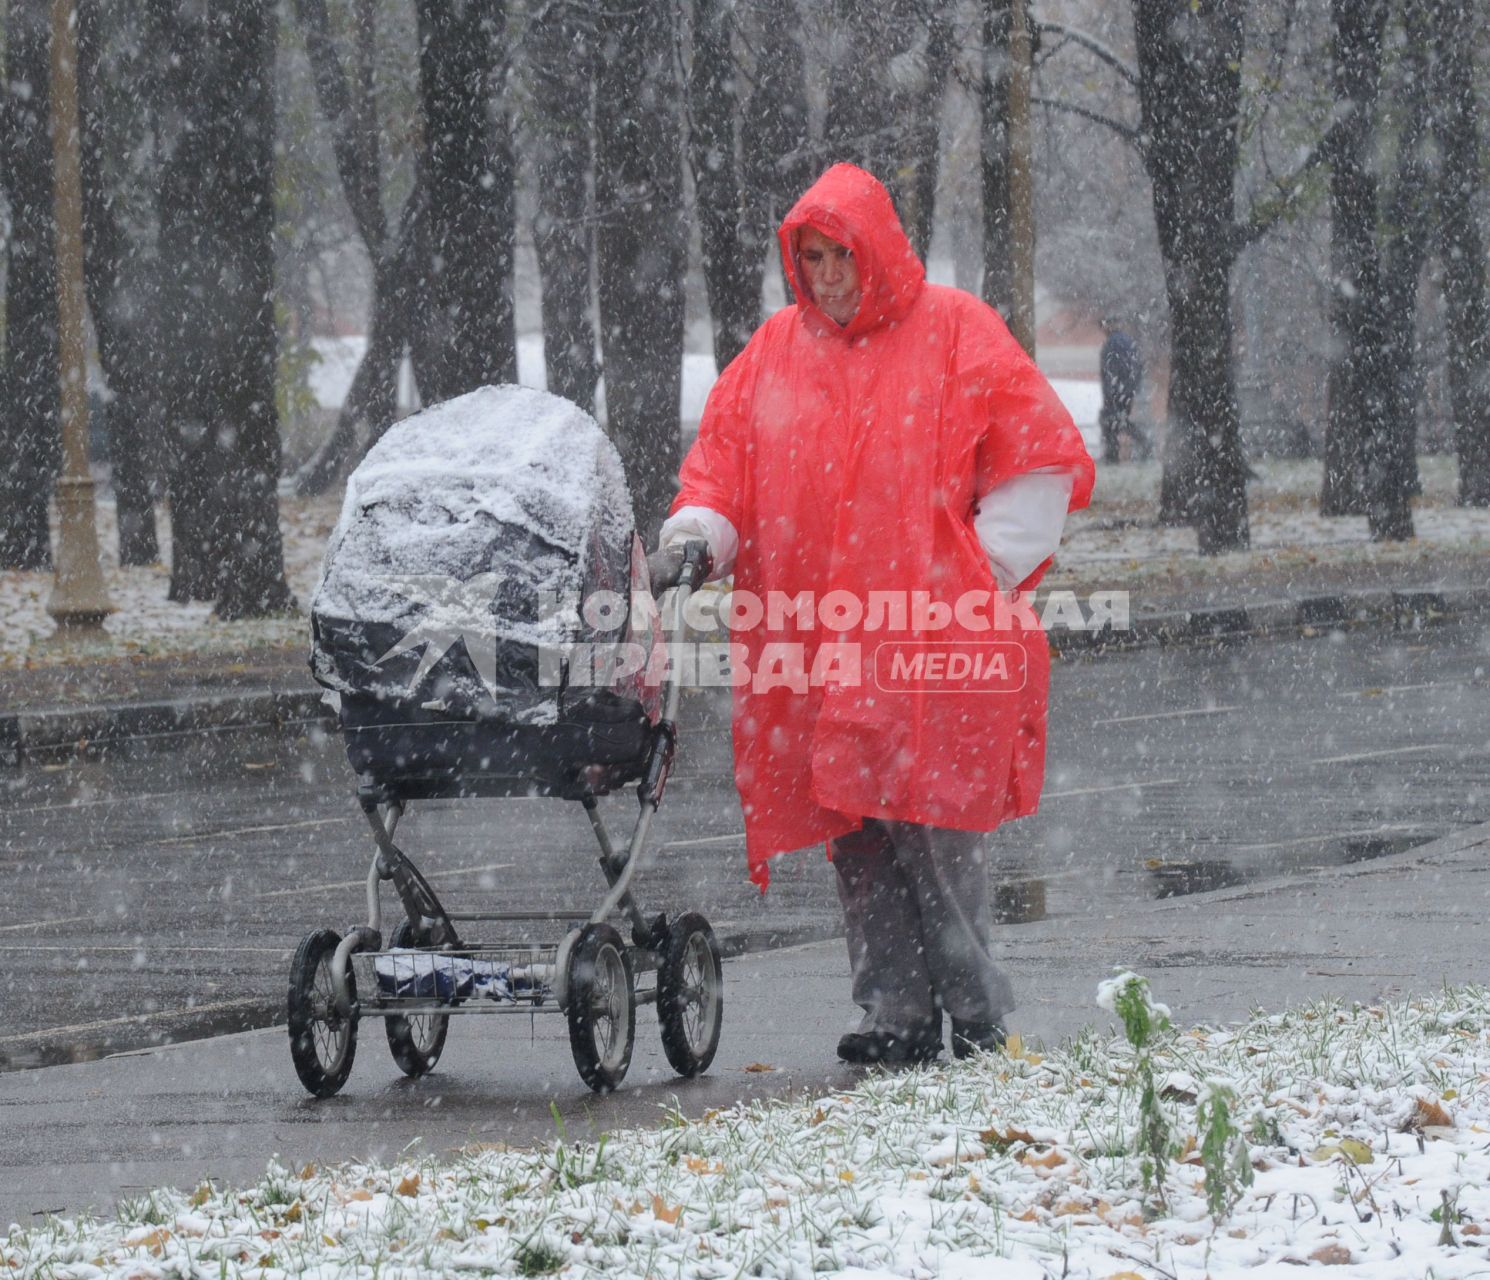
[289,541,723,1097]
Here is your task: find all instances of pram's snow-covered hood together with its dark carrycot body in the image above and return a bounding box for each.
[311,386,660,796]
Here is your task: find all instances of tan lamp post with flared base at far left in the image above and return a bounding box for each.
[46,0,113,635]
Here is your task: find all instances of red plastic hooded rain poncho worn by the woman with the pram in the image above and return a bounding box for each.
[673,164,1094,888]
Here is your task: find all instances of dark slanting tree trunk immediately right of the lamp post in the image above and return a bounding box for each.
[77,0,161,565]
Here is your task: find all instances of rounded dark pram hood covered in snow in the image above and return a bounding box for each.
[311,386,656,724]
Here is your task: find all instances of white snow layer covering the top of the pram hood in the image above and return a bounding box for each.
[313,378,633,644]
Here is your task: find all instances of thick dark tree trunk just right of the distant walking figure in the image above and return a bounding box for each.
[1132,0,1250,554]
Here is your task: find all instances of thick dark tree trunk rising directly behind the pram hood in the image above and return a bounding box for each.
[416,0,517,402]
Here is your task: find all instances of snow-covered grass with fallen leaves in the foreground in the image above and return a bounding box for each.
[0,988,1490,1280]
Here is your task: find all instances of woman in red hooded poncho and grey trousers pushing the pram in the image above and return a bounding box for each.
[660,164,1092,1062]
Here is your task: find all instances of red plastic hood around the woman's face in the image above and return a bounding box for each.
[778,164,927,337]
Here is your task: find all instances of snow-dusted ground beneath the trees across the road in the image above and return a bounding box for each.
[0,456,1490,668]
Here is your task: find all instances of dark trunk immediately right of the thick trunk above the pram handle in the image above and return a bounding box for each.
[688,0,763,370]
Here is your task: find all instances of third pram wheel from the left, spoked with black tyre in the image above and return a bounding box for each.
[565,924,636,1094]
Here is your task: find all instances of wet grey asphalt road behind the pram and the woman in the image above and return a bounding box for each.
[0,620,1490,1066]
